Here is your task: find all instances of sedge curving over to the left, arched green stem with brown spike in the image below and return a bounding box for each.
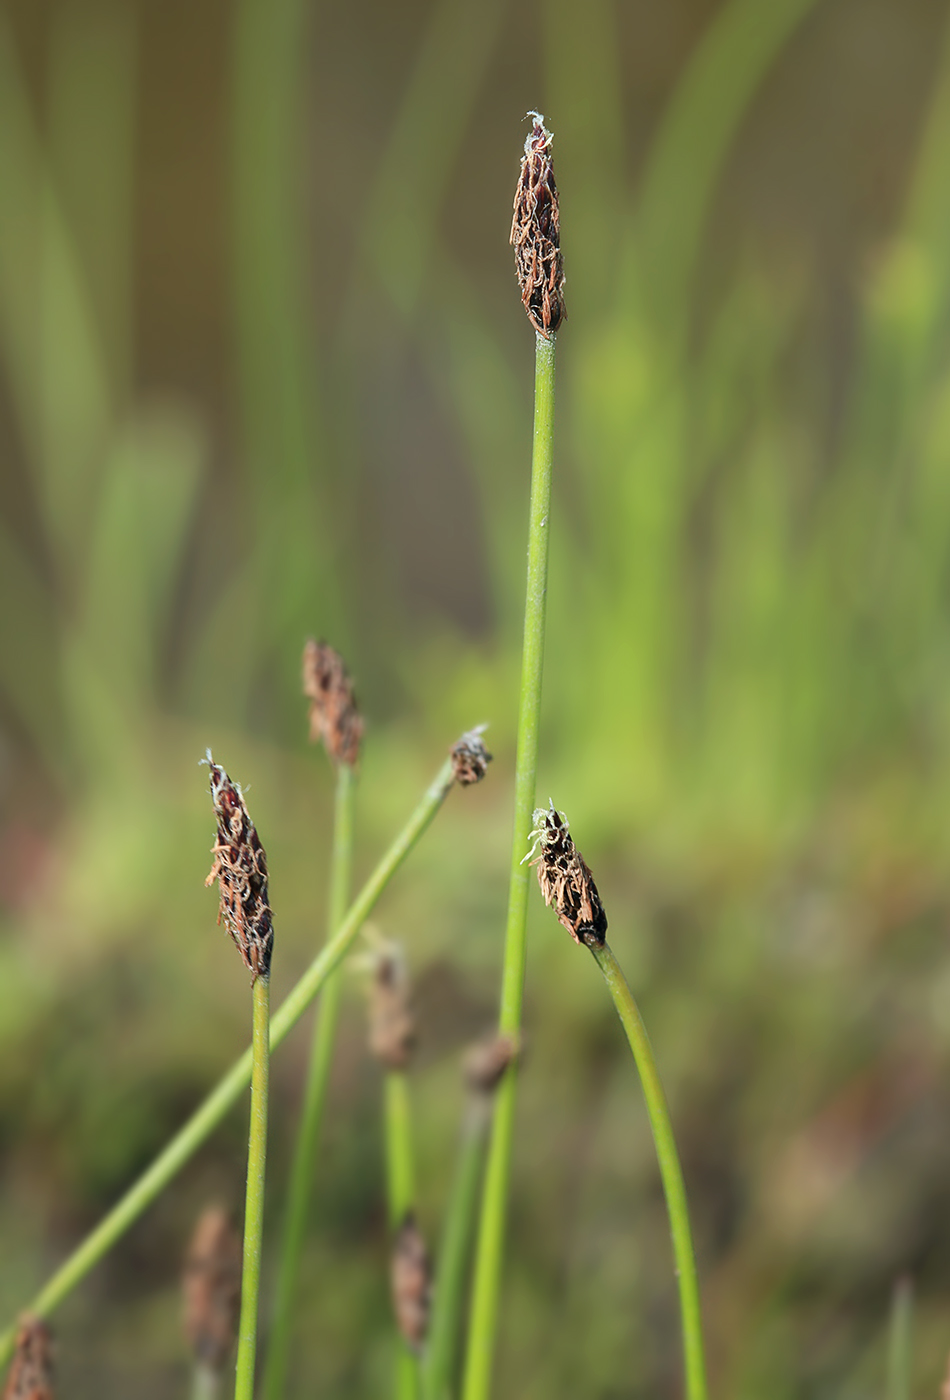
[523,804,707,1400]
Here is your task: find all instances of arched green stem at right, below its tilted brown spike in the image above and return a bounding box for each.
[590,944,707,1400]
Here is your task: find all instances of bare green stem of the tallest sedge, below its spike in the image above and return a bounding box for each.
[462,324,554,1400]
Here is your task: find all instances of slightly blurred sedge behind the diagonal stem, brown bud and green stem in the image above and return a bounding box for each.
[263,640,364,1400]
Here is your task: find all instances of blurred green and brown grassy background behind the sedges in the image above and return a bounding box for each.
[0,0,950,1400]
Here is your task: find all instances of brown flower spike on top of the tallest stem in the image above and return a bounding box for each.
[511,112,567,340]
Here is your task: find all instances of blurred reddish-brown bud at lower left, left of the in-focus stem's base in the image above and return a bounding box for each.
[182,1205,241,1372]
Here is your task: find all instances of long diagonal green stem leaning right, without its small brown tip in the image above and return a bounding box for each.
[0,759,455,1366]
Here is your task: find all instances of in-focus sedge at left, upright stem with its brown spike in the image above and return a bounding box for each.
[206,749,274,1400]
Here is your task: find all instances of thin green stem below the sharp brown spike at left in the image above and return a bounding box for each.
[234,977,270,1400]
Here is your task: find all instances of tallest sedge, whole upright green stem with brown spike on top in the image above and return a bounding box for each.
[463,113,564,1400]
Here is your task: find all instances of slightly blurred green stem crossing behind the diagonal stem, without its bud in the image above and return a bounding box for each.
[263,763,357,1400]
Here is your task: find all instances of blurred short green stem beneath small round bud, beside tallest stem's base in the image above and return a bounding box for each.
[423,1099,490,1400]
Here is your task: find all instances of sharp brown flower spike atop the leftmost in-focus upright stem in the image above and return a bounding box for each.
[204,749,274,987]
